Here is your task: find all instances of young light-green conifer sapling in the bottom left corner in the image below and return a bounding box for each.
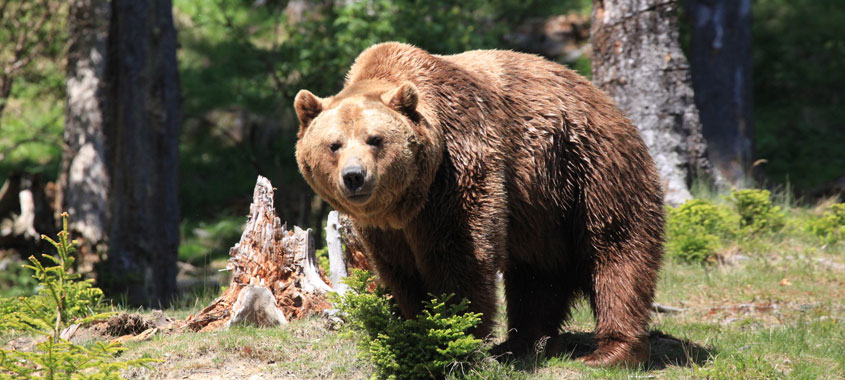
[0,213,153,379]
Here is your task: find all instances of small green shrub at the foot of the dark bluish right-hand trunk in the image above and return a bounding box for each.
[727,189,785,233]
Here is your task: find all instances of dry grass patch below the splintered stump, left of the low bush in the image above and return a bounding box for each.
[121,319,370,379]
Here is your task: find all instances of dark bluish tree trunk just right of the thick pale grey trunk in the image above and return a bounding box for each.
[686,0,753,186]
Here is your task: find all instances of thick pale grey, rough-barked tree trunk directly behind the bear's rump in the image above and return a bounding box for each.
[590,0,712,204]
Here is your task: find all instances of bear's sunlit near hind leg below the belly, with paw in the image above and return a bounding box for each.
[580,251,657,366]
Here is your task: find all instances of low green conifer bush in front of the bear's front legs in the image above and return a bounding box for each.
[333,270,482,380]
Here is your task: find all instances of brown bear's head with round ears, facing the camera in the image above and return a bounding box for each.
[294,80,442,228]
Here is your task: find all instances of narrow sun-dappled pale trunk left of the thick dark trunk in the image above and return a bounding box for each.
[55,0,110,266]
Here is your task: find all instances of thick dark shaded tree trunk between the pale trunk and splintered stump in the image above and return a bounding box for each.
[98,0,180,307]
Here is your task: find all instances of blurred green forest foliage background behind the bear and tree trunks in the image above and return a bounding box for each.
[0,0,845,268]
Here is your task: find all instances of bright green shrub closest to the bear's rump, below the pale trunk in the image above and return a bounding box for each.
[666,199,731,263]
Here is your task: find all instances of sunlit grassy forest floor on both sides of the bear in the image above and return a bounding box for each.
[109,239,845,379]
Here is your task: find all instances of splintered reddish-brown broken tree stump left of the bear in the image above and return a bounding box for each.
[186,176,332,331]
